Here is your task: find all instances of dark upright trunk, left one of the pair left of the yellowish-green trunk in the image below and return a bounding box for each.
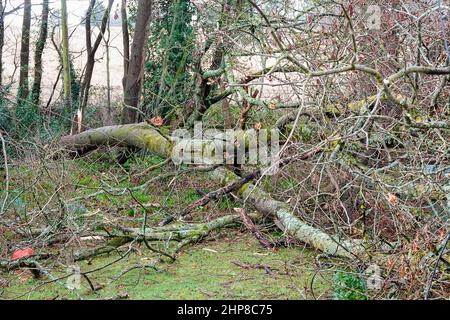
[17,0,31,102]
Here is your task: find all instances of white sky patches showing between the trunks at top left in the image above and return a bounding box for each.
[6,0,120,26]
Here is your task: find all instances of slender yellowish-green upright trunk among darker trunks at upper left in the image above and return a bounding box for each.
[61,0,72,122]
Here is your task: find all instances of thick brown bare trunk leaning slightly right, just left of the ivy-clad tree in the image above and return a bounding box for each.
[122,0,152,124]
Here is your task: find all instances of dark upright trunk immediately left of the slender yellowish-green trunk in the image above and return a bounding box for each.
[31,0,49,108]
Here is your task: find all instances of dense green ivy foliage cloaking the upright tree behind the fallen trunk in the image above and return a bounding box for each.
[144,0,195,117]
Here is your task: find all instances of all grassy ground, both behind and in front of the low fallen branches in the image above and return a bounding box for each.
[0,152,362,299]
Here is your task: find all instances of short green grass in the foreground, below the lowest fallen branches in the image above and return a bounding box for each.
[0,232,332,299]
